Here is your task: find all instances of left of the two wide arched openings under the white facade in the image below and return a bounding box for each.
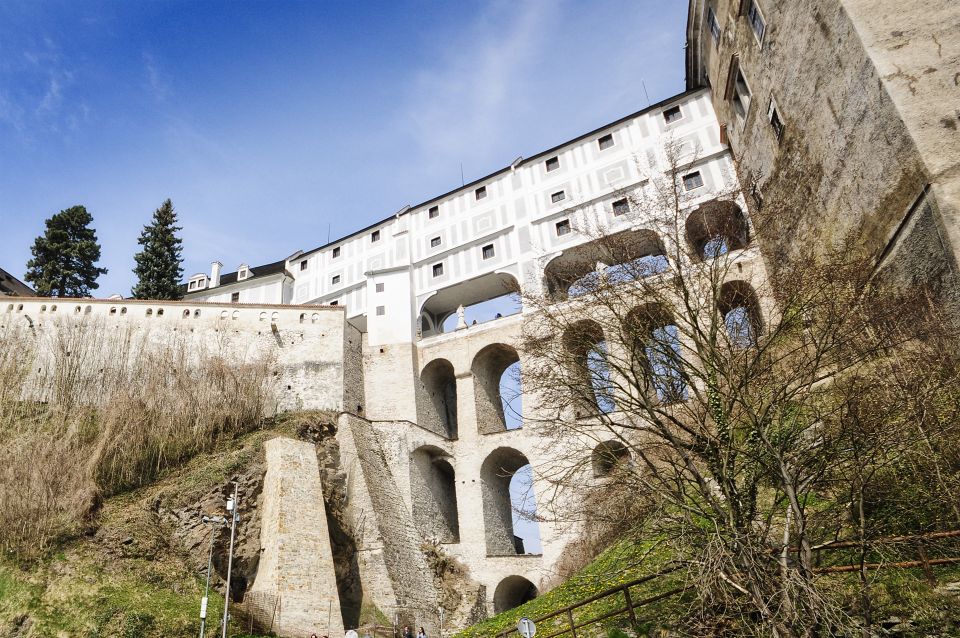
[420,273,521,337]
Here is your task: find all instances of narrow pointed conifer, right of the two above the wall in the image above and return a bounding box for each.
[133,199,183,299]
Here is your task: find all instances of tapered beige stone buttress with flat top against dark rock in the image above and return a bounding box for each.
[250,438,343,636]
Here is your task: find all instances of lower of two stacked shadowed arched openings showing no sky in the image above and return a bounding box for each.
[410,446,460,543]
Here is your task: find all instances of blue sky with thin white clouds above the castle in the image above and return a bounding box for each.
[0,0,687,296]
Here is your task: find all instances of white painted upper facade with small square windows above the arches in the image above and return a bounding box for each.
[186,90,735,345]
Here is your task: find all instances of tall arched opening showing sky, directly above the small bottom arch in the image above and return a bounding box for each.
[480,447,540,556]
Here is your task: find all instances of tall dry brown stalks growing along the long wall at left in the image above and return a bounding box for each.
[0,322,273,560]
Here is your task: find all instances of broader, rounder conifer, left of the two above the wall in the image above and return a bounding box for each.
[24,206,107,297]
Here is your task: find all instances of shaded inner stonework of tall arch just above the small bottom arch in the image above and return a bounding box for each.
[480,447,530,556]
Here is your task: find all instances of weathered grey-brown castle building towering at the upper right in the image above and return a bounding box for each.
[686,0,960,317]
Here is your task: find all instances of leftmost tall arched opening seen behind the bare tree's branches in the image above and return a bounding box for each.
[563,319,617,418]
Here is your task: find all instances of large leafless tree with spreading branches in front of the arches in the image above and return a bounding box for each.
[522,147,960,636]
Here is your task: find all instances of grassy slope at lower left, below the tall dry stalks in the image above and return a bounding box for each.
[0,424,289,638]
